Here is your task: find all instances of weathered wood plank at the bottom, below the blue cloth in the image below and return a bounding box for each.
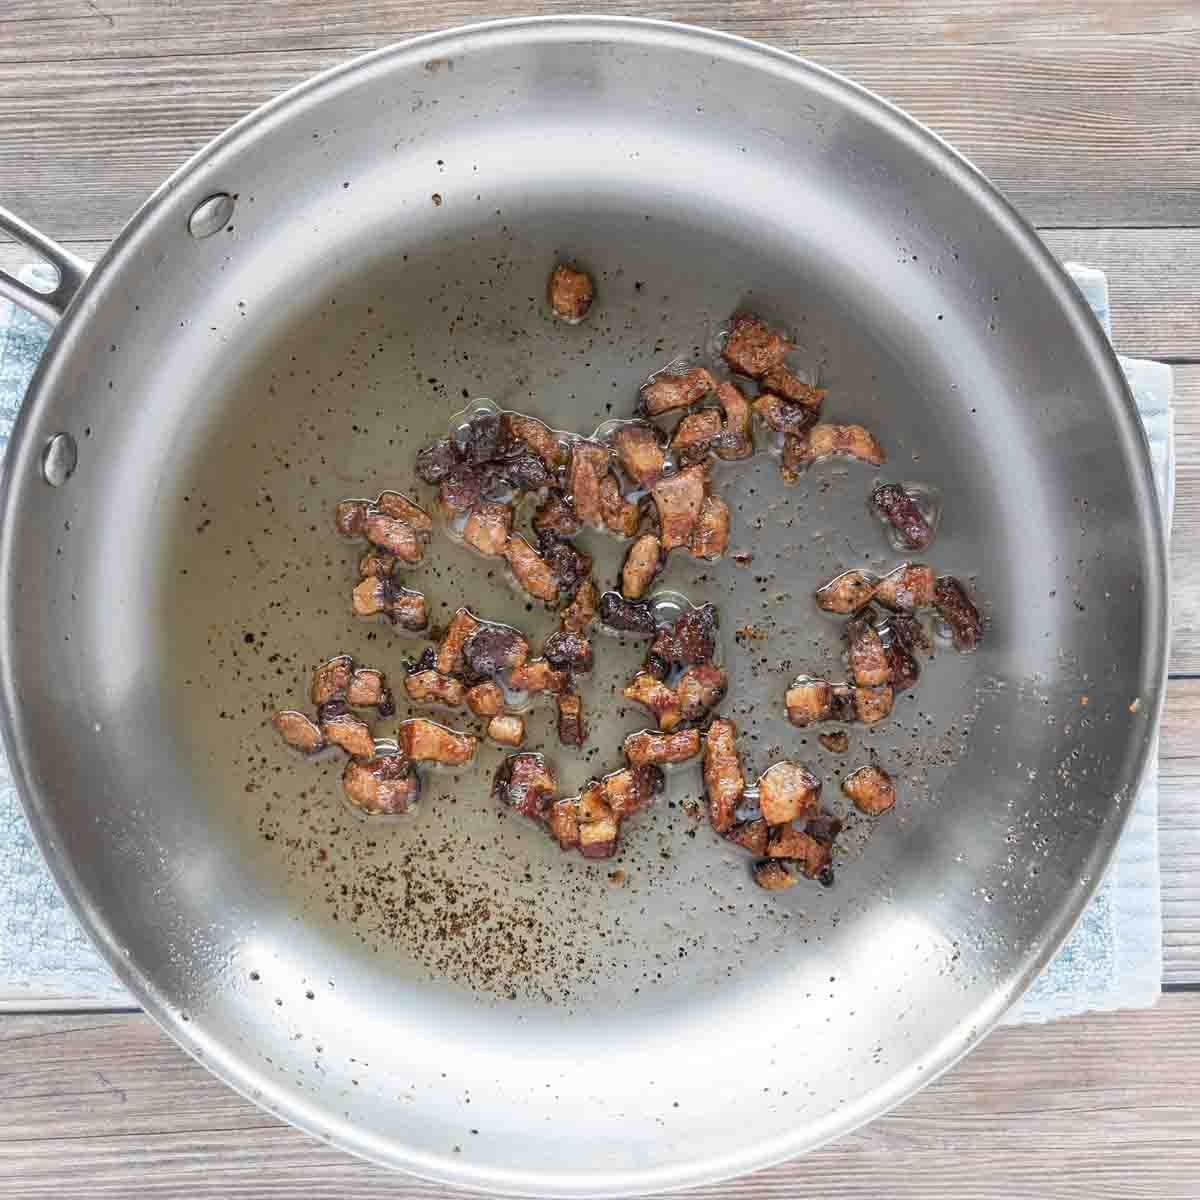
[0,994,1200,1200]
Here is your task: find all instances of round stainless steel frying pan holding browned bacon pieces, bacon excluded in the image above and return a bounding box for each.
[0,19,1165,1196]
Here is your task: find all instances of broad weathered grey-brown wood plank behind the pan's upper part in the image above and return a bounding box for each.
[0,31,1200,240]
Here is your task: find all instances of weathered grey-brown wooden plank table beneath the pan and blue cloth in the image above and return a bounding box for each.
[0,0,1200,1200]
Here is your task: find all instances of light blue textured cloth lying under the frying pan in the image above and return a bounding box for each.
[0,266,1175,1022]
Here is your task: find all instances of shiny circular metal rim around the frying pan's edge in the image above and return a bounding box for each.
[0,16,1168,1196]
